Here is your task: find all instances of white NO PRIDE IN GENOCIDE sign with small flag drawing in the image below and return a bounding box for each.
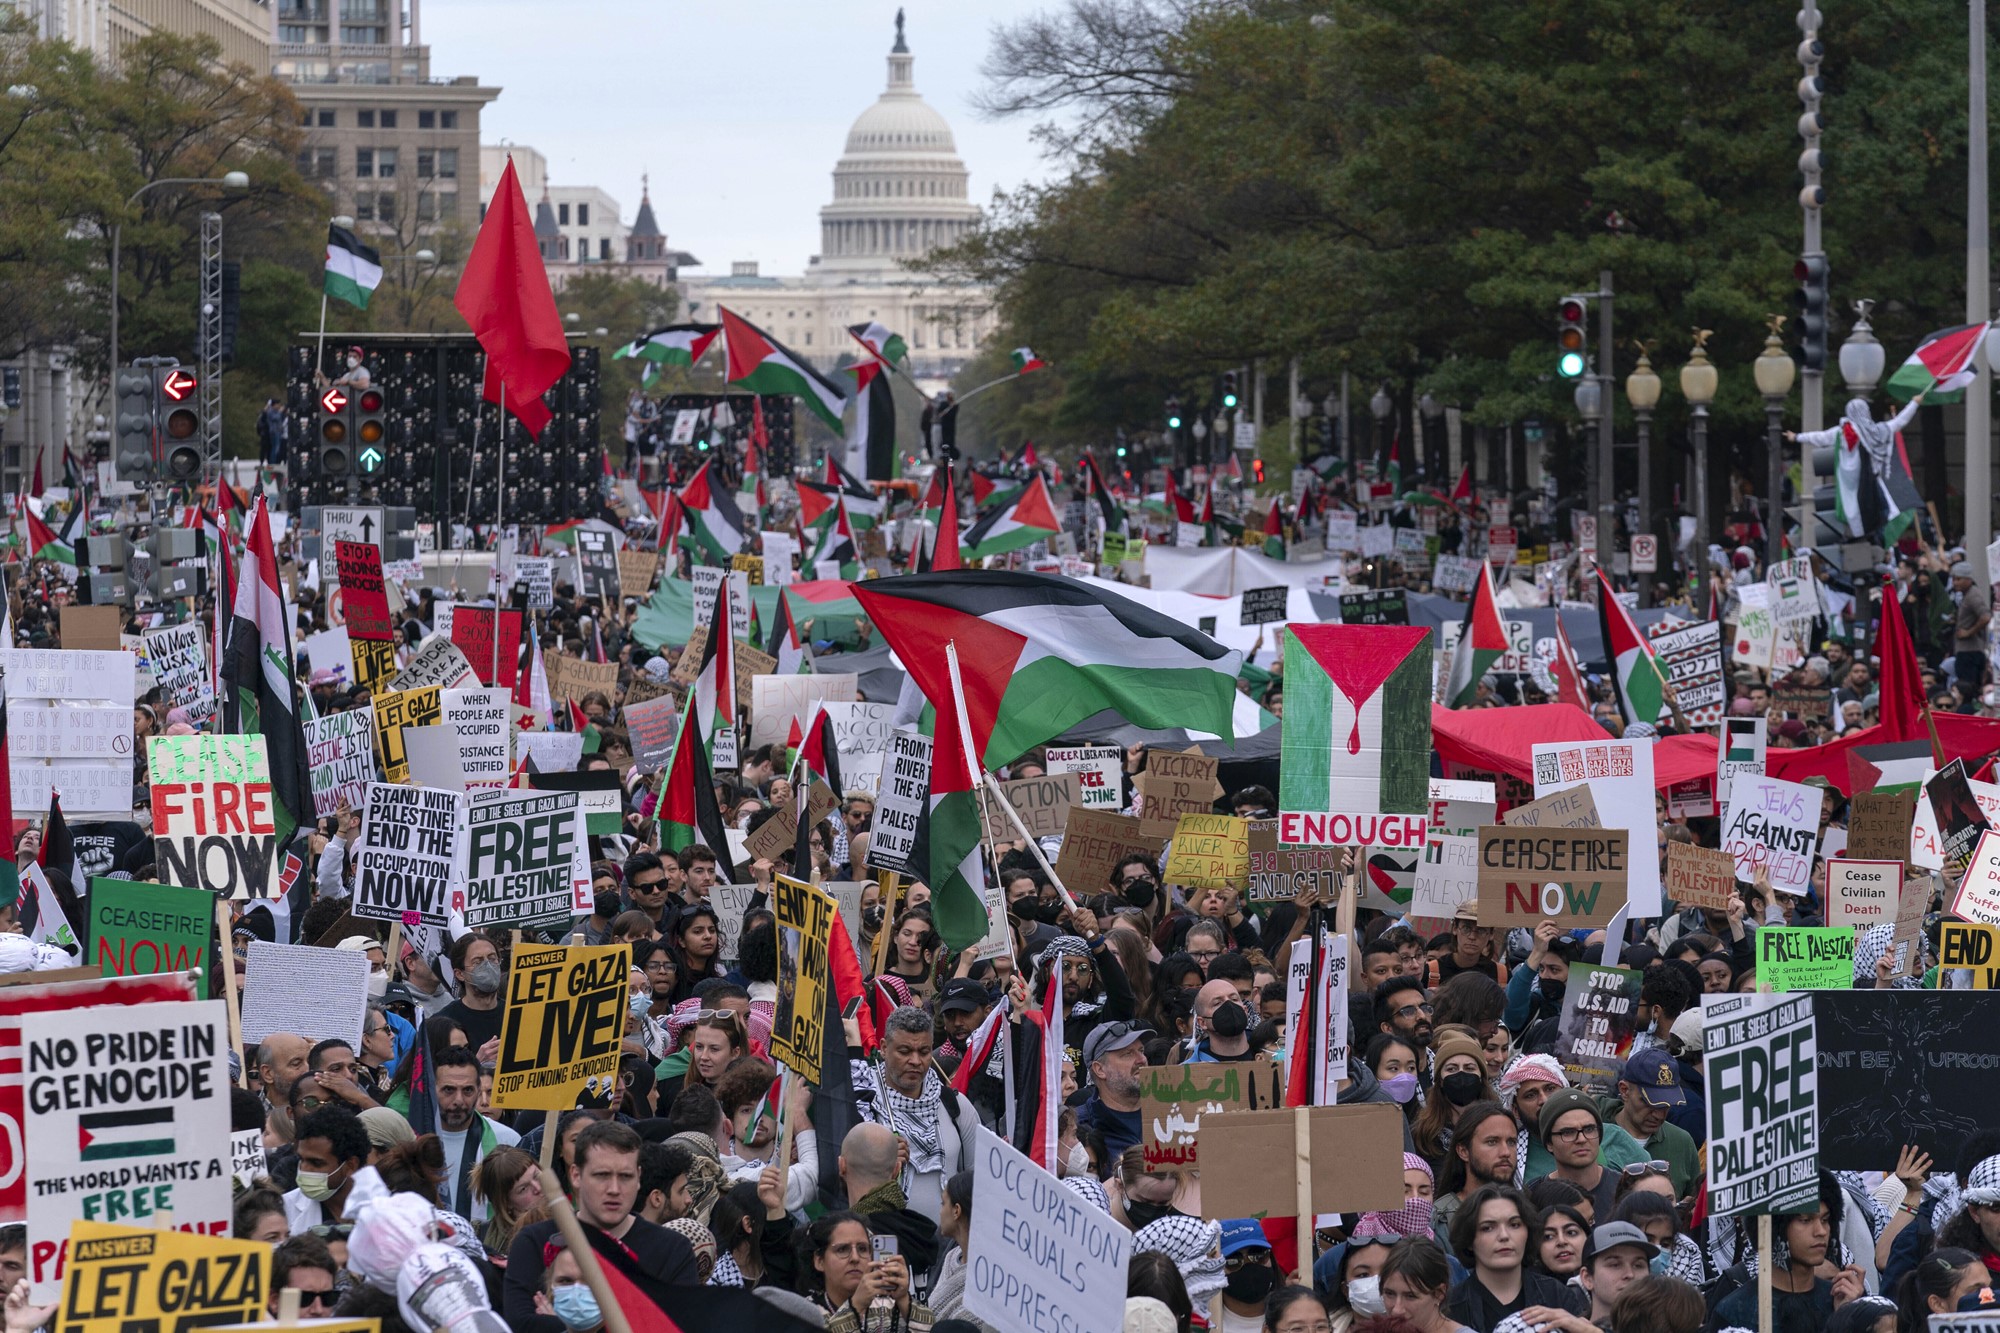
[16,1001,232,1301]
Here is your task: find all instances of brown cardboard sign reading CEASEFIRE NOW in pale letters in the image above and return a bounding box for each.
[1478,811,1624,931]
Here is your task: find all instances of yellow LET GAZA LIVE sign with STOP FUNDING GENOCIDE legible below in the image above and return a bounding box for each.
[494,945,632,1111]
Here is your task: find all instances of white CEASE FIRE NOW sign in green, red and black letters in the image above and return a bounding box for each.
[146,737,278,899]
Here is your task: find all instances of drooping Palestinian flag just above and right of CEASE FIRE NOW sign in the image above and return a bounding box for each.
[222,494,312,849]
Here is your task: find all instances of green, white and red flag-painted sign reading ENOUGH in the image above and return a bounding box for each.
[1278,624,1430,847]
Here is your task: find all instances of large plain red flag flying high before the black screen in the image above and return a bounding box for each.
[452,158,570,436]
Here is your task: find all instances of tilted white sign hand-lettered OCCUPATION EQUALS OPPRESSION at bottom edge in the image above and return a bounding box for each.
[966,1125,1132,1331]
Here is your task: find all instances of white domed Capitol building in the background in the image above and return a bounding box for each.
[678,12,996,390]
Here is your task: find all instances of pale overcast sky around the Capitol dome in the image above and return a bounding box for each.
[420,0,1060,274]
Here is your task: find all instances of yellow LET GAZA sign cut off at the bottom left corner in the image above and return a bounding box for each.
[54,1221,270,1333]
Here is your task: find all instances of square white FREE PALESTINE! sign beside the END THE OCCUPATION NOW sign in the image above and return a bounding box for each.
[464,789,590,931]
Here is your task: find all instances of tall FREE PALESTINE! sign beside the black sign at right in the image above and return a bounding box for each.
[1702,984,1820,1217]
